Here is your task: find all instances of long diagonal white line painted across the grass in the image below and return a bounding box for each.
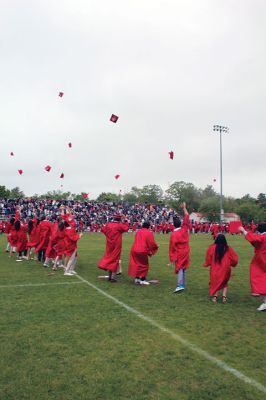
[76,274,266,393]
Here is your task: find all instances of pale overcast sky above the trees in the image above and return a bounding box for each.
[0,0,266,198]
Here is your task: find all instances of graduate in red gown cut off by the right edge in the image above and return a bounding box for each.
[239,222,266,311]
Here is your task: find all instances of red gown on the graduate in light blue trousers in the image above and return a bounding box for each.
[169,214,190,273]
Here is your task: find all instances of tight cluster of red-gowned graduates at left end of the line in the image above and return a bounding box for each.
[5,207,82,276]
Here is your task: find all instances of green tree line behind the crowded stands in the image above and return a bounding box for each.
[0,181,266,223]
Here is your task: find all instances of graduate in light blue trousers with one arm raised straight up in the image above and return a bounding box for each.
[169,202,190,293]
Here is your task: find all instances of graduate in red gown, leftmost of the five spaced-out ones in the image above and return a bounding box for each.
[98,215,129,282]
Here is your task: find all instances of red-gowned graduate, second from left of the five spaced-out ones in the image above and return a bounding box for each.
[128,222,158,285]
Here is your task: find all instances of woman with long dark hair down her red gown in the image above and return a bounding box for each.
[204,233,238,303]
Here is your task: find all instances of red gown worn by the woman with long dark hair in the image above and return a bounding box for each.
[204,244,238,296]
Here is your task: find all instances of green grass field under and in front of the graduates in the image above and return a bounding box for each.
[0,234,266,400]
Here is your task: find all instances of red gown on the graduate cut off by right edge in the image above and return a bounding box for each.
[245,232,266,295]
